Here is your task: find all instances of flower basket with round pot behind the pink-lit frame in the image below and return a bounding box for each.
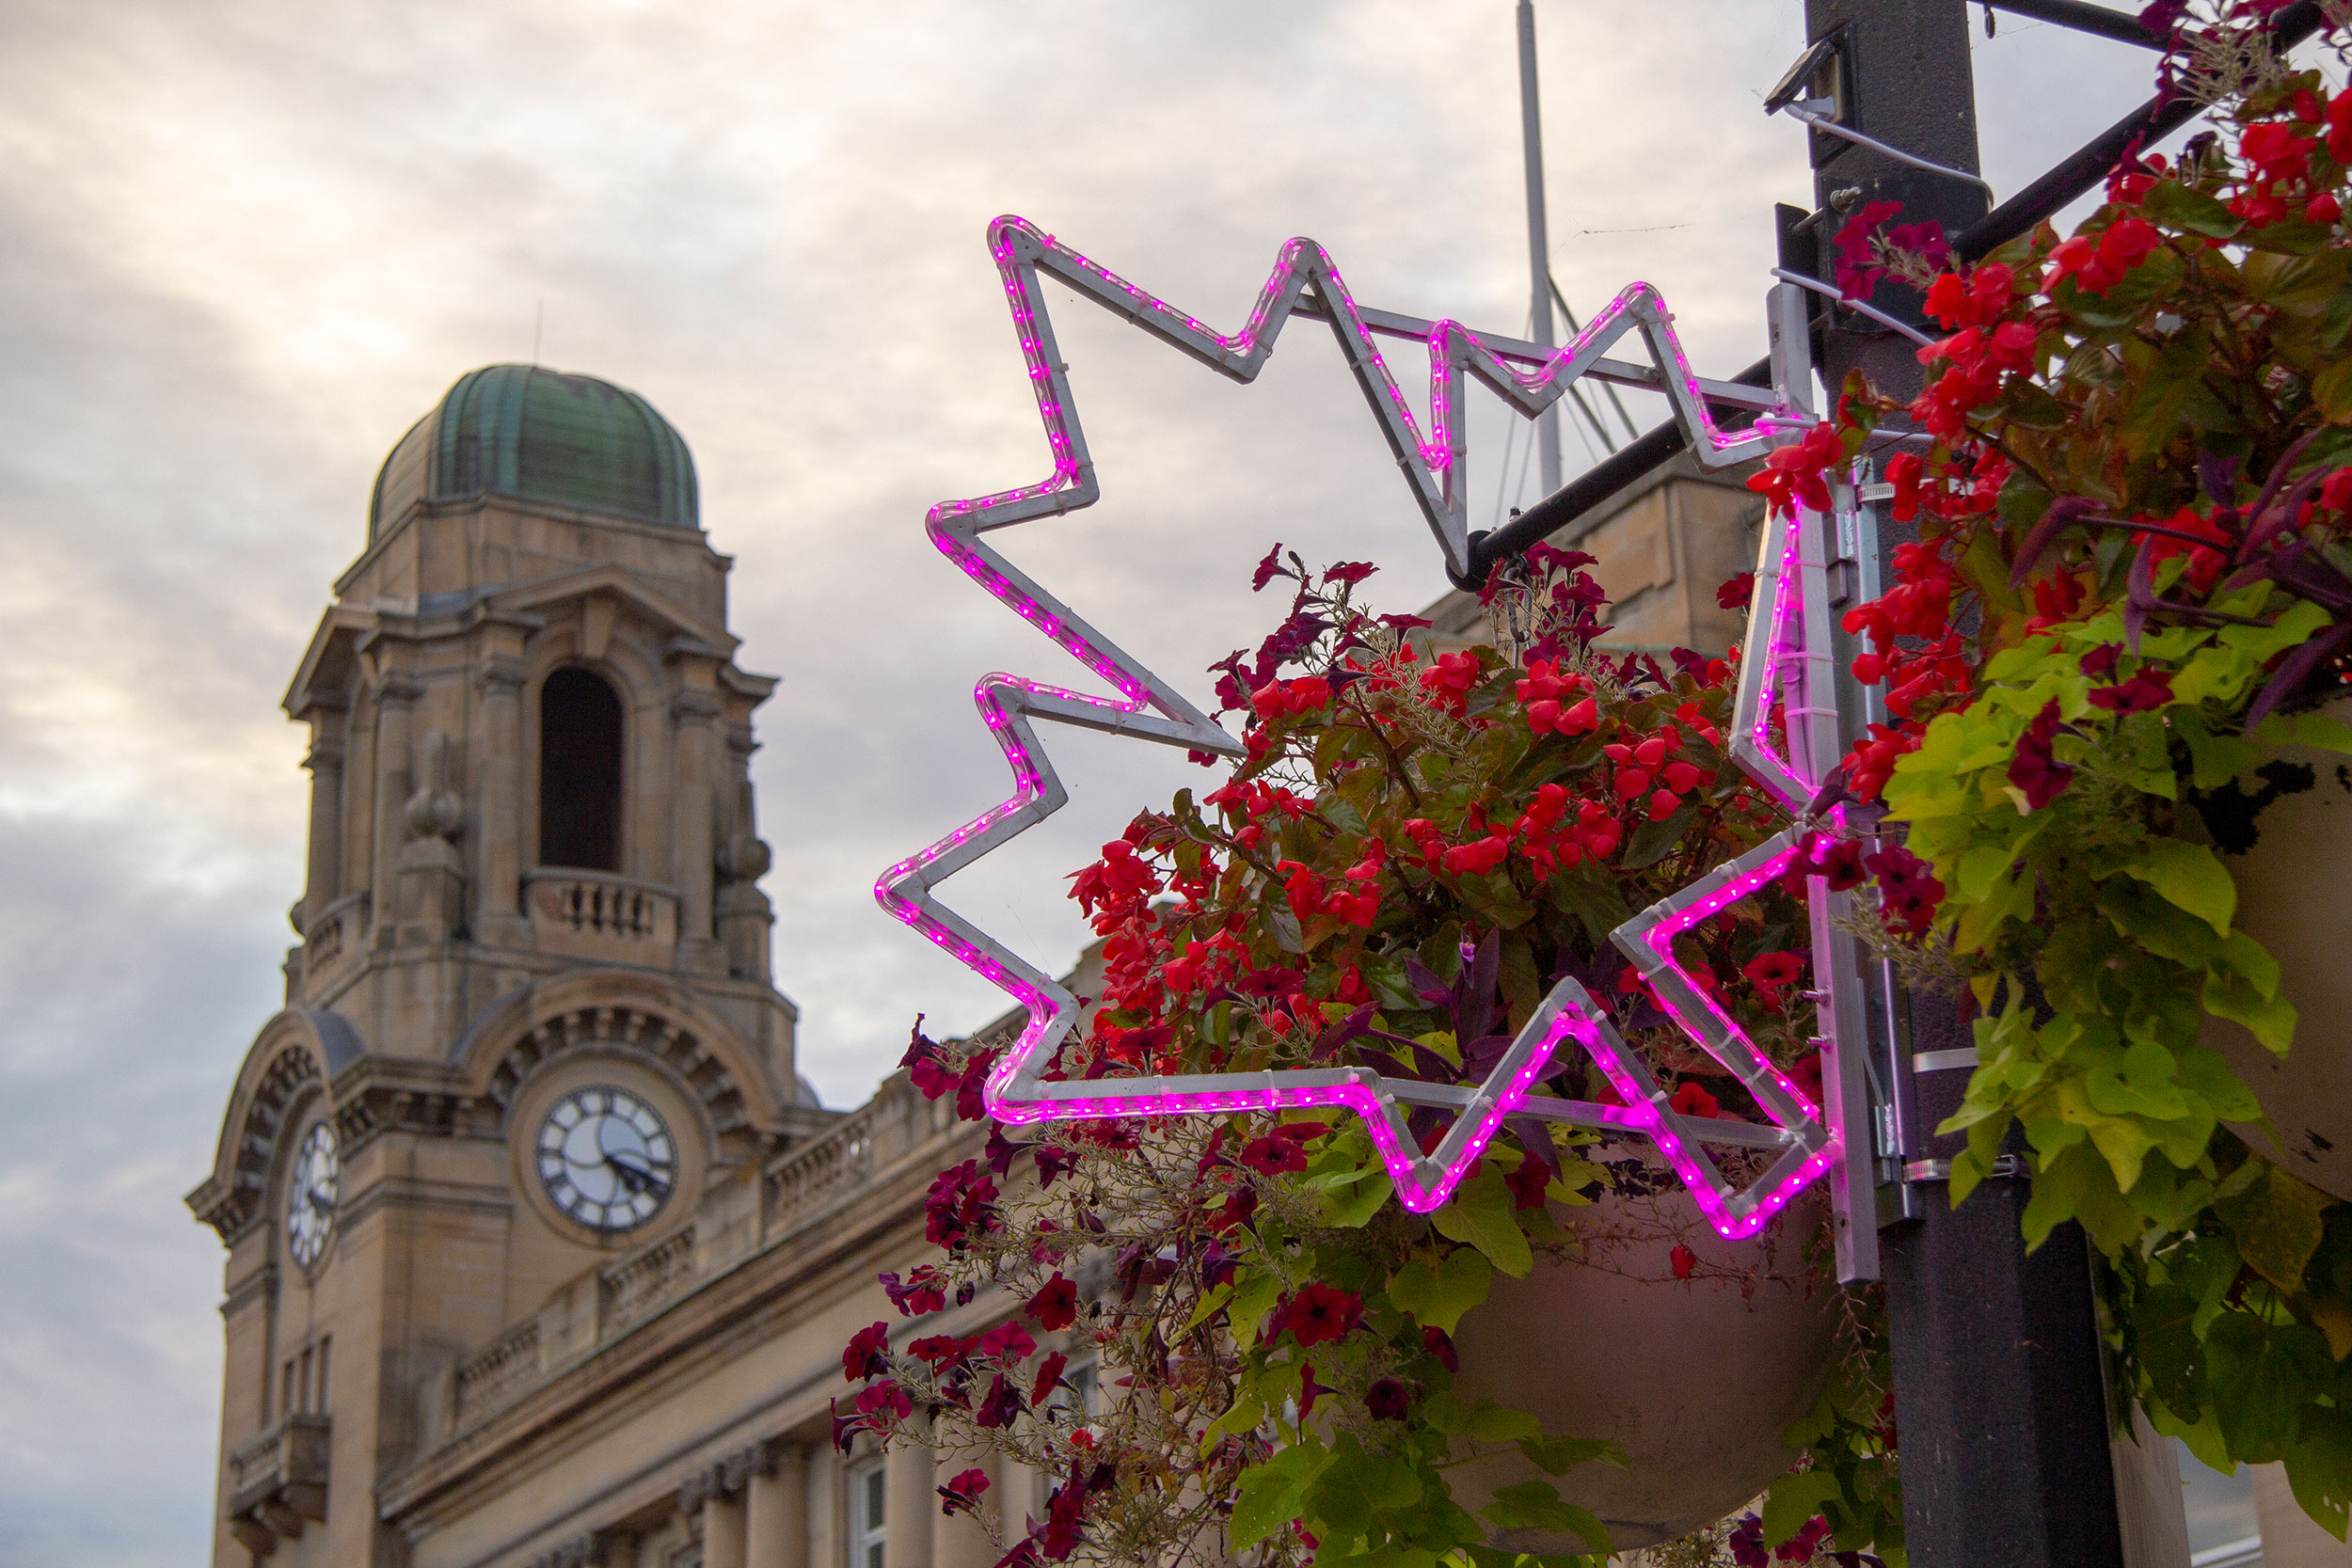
[840,547,1894,1568]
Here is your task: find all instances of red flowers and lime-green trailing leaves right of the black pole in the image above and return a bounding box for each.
[1757,5,2352,1535]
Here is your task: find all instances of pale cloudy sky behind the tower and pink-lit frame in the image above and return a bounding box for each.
[0,0,2183,1568]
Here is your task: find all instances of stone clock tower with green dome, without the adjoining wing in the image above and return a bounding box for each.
[188,364,831,1568]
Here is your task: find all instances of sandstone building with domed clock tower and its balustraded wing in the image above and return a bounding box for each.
[188,364,1082,1568]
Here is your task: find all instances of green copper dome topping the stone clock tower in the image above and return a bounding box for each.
[367,364,701,538]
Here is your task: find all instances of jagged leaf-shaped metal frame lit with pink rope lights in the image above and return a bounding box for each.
[875,216,1842,1237]
